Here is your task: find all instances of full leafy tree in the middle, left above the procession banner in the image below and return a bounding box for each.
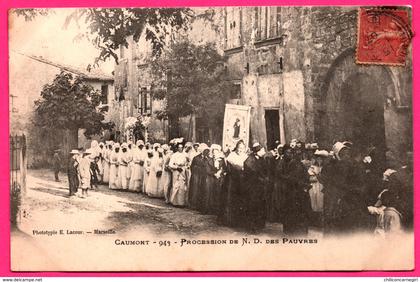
[151,40,233,139]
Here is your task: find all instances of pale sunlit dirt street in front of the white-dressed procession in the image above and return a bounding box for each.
[16,170,298,237]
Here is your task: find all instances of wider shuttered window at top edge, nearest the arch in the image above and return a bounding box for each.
[255,7,281,41]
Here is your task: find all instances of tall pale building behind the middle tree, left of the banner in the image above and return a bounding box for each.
[109,8,223,142]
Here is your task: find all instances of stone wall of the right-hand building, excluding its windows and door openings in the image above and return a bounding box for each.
[225,7,412,164]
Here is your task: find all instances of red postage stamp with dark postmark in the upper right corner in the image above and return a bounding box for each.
[356,8,413,66]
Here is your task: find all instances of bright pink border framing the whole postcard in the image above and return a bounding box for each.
[0,0,420,277]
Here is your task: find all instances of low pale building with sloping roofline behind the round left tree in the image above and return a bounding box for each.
[9,50,114,167]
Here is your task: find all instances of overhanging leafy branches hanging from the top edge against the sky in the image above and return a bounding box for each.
[65,8,193,64]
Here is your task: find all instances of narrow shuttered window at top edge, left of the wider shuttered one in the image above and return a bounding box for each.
[225,7,242,49]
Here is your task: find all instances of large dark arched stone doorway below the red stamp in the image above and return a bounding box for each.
[316,50,396,169]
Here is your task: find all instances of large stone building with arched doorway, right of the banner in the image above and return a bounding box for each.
[222,7,412,166]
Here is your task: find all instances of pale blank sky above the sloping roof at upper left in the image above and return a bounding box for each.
[9,9,114,74]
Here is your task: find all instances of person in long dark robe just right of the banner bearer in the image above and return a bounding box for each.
[244,143,268,232]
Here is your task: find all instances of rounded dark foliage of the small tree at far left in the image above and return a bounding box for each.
[35,72,112,137]
